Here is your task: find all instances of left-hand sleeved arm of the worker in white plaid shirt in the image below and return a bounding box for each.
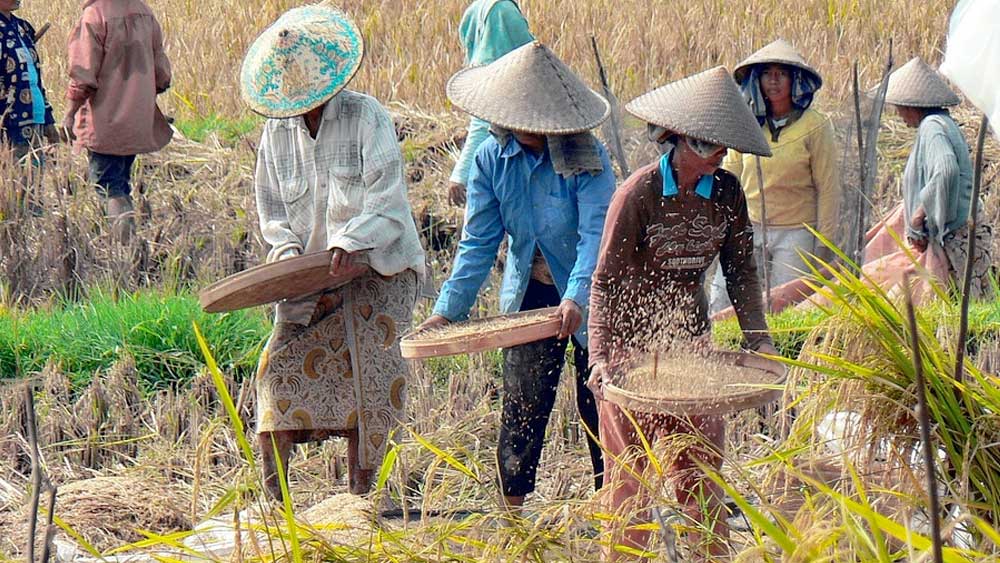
[254,125,305,262]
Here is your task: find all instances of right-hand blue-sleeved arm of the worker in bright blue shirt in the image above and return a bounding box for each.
[563,148,615,308]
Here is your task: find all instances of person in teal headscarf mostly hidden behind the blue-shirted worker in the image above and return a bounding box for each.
[448,0,534,206]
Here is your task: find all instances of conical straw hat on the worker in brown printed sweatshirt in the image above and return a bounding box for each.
[625,66,771,156]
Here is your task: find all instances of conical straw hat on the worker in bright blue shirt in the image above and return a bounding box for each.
[447,41,611,135]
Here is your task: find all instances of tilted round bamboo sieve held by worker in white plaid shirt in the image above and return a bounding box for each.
[198,250,364,313]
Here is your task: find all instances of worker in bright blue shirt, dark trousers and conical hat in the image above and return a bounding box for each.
[421,43,615,509]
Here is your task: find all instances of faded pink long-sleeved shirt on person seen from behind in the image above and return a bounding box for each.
[66,0,173,155]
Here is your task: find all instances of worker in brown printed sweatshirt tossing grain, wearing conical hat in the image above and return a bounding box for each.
[588,67,776,559]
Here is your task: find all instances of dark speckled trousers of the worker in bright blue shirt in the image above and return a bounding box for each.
[497,280,604,496]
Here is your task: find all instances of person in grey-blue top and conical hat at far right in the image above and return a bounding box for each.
[885,57,993,298]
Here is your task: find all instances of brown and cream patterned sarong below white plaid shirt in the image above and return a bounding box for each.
[255,270,417,469]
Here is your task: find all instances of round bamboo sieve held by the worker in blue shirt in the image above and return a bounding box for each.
[400,307,562,360]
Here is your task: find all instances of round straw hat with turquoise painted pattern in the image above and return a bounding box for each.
[240,3,365,118]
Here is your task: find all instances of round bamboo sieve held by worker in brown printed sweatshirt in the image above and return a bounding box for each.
[604,351,787,416]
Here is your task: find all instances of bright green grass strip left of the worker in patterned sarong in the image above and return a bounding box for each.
[0,291,270,391]
